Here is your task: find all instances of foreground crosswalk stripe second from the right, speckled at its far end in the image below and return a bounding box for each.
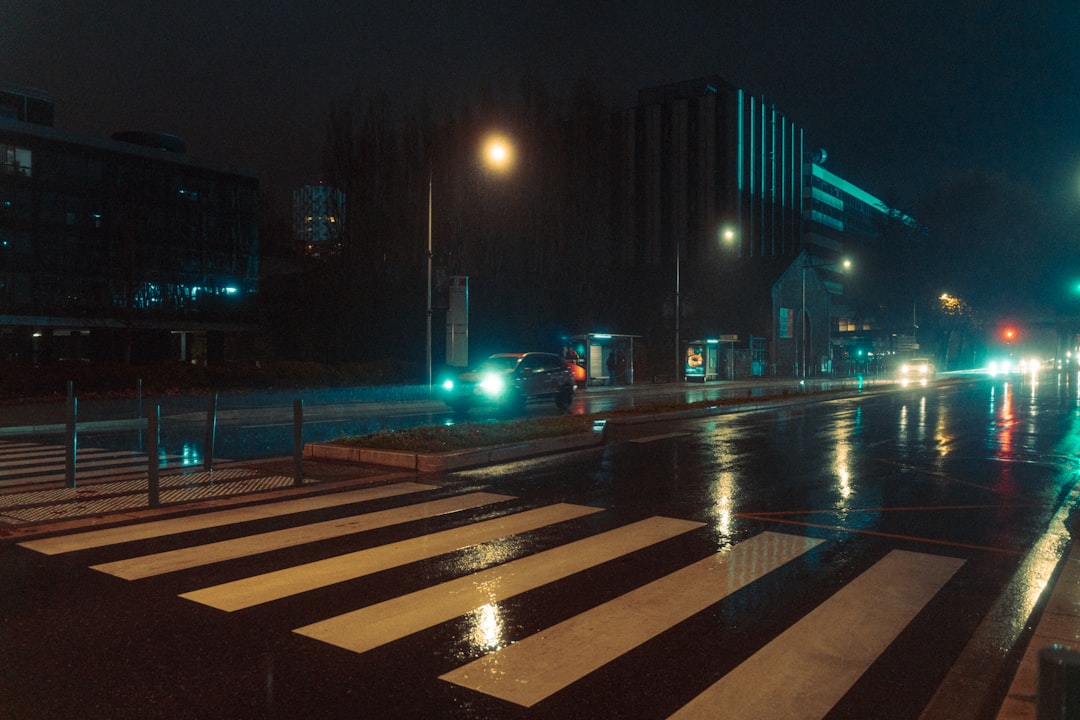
[442,532,825,707]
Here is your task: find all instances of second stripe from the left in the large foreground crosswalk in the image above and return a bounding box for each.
[91,492,513,580]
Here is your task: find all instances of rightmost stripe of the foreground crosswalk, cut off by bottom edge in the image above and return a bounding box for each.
[672,551,963,720]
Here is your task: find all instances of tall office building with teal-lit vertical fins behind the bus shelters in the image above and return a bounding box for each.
[611,77,917,377]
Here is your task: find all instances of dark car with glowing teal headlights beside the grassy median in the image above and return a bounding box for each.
[441,353,575,415]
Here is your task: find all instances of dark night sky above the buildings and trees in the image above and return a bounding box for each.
[0,0,1080,216]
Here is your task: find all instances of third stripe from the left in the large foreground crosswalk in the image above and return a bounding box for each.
[180,503,602,612]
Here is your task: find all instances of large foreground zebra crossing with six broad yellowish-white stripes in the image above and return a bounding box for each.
[21,483,964,718]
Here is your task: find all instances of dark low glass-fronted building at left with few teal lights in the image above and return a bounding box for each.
[0,92,259,362]
